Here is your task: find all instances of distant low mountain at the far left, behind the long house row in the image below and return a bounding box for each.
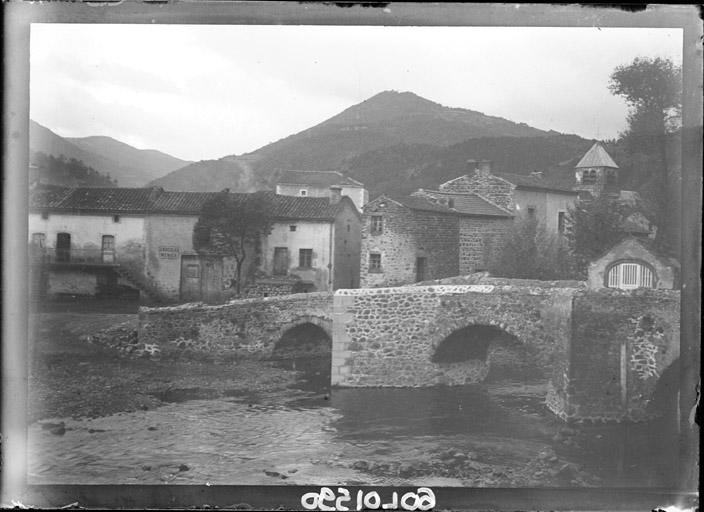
[29,120,190,187]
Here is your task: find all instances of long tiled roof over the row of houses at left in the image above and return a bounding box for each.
[30,187,356,220]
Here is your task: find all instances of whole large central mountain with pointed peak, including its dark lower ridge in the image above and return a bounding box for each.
[152,91,588,194]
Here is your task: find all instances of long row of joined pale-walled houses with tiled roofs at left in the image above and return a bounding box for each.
[29,186,360,301]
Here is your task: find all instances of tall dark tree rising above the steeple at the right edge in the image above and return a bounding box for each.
[609,57,682,245]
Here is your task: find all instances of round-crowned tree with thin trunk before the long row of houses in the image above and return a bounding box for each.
[193,189,273,295]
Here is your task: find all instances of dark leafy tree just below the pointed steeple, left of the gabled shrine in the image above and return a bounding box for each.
[565,196,626,274]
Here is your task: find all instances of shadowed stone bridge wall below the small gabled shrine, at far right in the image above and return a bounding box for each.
[548,289,680,421]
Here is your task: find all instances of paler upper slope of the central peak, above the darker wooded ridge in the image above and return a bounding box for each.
[153,91,558,190]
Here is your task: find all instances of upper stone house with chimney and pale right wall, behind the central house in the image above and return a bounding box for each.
[438,160,579,234]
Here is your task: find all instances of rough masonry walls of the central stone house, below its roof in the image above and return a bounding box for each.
[360,200,459,287]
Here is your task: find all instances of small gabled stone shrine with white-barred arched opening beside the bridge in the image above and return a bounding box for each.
[587,236,679,290]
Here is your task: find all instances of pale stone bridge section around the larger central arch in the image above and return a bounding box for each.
[332,285,572,386]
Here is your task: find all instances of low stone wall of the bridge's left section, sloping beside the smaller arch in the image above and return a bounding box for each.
[139,292,332,359]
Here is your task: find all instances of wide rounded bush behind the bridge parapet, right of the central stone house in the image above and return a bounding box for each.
[489,219,575,280]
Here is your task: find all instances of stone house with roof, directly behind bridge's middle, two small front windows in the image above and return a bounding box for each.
[360,190,512,287]
